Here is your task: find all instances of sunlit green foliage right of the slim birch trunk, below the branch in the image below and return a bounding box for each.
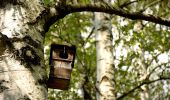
[114,17,170,100]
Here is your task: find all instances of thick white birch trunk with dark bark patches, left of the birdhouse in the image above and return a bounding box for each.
[0,0,47,100]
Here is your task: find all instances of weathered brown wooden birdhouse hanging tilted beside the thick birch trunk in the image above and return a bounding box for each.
[47,43,76,90]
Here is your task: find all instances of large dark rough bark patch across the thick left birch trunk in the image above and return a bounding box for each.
[0,33,40,70]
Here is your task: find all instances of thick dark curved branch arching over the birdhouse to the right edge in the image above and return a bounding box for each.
[43,3,170,31]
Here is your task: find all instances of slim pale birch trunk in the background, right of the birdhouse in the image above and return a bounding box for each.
[94,13,116,100]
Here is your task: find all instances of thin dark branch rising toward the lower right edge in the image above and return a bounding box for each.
[117,77,170,100]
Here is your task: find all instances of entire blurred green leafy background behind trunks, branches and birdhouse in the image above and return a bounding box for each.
[45,0,170,100]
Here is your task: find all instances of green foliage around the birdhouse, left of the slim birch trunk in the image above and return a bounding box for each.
[45,13,96,100]
